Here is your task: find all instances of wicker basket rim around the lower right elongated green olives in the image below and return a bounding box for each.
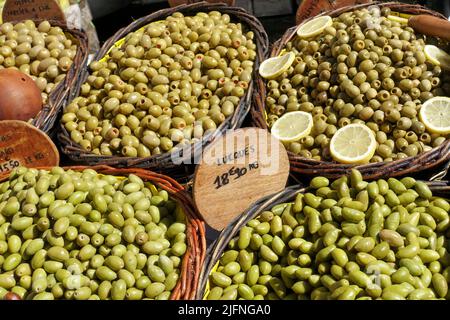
[197,181,450,300]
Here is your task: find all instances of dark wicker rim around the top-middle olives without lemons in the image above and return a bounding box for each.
[58,2,268,172]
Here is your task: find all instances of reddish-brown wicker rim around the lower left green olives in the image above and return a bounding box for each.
[0,166,206,300]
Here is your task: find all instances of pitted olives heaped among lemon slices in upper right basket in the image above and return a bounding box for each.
[266,8,450,162]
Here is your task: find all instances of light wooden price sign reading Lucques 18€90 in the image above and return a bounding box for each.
[193,128,289,230]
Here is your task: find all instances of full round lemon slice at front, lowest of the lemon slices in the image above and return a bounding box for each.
[330,123,377,164]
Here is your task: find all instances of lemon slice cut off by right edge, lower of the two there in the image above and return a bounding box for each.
[419,97,450,134]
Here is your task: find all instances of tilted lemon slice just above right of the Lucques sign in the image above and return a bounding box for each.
[271,111,313,142]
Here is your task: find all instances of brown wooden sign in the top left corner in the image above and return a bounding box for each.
[3,0,66,23]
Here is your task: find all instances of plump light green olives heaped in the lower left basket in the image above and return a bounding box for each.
[0,167,186,300]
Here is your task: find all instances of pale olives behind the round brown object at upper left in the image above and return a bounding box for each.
[0,20,77,103]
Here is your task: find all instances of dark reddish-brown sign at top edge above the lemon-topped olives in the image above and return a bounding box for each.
[296,0,372,24]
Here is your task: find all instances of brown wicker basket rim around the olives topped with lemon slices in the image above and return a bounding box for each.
[251,2,450,179]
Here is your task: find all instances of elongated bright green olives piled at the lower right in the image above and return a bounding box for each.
[208,170,450,300]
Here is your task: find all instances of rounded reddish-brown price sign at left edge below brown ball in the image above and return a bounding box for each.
[0,120,59,173]
